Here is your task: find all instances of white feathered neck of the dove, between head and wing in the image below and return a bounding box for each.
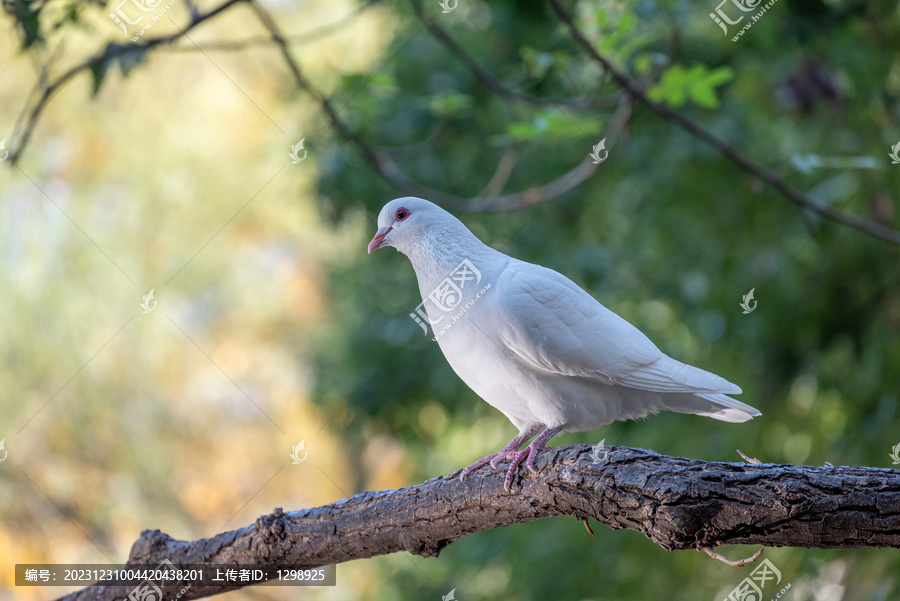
[403,221,509,290]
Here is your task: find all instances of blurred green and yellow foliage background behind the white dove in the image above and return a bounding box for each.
[0,0,900,601]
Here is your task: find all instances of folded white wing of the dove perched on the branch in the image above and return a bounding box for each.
[491,261,755,396]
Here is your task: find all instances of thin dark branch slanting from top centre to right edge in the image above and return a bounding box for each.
[550,0,900,245]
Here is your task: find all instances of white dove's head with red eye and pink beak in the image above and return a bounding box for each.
[369,196,468,256]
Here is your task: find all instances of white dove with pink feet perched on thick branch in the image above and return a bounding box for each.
[369,197,761,491]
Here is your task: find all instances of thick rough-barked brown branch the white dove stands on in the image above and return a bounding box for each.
[54,445,900,601]
